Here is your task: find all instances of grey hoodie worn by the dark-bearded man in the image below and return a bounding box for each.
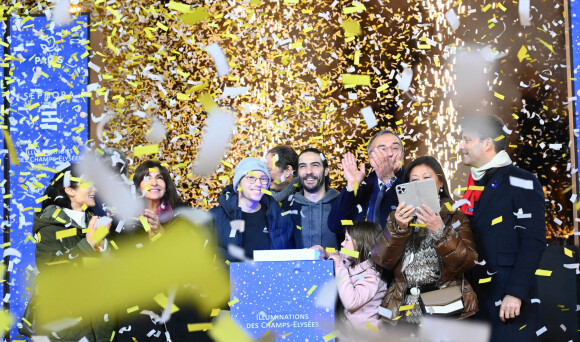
[282,189,340,248]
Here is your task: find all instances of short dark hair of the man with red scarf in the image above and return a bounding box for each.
[459,114,507,153]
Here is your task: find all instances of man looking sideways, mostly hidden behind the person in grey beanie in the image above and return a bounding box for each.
[265,145,298,202]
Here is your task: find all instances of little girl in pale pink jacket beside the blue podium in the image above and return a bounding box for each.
[328,221,387,335]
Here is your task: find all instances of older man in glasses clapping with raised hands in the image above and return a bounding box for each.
[328,129,404,233]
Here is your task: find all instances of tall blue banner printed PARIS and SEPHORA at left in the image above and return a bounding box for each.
[5,15,90,338]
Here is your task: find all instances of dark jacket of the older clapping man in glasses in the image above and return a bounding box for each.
[328,168,405,234]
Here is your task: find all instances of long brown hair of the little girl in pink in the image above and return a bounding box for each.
[346,221,382,272]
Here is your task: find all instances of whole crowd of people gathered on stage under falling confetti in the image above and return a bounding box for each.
[23,115,546,341]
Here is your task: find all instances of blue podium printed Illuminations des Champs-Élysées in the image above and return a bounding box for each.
[230,260,334,342]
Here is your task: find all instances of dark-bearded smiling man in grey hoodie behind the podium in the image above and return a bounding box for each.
[282,148,343,248]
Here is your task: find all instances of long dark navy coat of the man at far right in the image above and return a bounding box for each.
[471,165,546,342]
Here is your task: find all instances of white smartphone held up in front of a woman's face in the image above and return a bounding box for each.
[395,179,441,216]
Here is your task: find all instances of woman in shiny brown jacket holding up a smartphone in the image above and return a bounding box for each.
[372,156,478,329]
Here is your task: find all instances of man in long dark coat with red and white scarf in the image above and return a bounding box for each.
[459,115,546,342]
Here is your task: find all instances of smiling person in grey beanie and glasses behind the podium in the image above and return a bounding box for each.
[210,157,294,261]
